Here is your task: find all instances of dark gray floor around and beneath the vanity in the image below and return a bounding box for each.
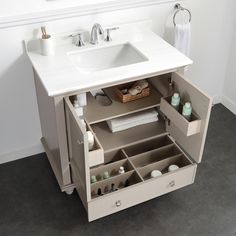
[0,105,236,236]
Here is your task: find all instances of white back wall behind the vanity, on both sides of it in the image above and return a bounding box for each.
[0,0,236,163]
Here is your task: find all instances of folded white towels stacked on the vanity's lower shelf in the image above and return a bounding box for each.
[107,108,158,133]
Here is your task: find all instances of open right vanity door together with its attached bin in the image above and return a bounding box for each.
[161,73,212,163]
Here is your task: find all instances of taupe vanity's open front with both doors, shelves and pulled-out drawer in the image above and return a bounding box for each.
[65,73,212,221]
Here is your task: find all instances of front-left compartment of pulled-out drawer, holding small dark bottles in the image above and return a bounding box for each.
[91,171,142,199]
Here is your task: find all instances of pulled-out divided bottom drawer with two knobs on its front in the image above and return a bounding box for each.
[87,136,197,221]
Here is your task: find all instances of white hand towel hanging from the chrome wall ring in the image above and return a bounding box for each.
[174,23,191,56]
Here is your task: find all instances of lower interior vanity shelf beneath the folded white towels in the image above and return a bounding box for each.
[91,115,166,152]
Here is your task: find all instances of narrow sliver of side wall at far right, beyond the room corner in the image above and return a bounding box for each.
[222,21,236,115]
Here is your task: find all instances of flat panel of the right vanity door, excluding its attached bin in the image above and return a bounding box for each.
[168,73,212,163]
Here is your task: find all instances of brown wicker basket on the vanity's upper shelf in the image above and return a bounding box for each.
[115,83,150,103]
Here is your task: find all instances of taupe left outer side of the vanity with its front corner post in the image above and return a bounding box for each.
[34,70,74,193]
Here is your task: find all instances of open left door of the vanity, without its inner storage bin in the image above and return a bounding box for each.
[65,97,91,209]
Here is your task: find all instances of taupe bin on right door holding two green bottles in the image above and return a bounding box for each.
[160,97,201,136]
